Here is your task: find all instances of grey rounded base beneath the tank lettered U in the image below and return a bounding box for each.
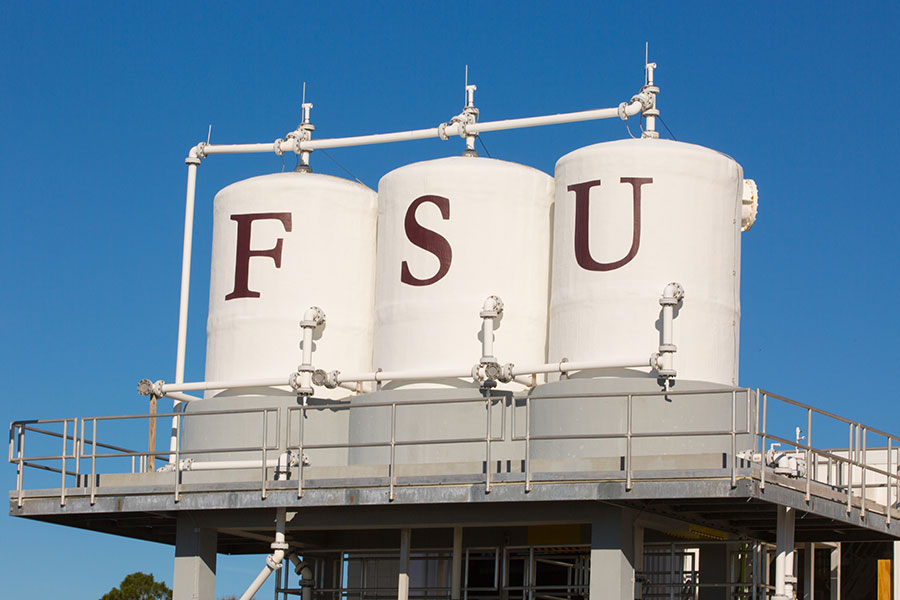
[529,376,753,471]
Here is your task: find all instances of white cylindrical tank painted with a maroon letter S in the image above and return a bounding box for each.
[374,156,553,386]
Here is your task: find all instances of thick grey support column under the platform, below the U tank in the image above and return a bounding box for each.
[590,503,634,600]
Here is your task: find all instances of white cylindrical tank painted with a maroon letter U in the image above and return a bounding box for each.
[549,139,743,385]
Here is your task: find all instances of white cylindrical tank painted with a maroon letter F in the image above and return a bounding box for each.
[206,173,377,390]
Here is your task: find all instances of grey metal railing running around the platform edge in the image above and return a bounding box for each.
[9,387,900,522]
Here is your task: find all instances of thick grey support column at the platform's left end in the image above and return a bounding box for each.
[172,514,218,600]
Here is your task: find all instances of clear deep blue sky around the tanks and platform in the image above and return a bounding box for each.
[0,2,900,600]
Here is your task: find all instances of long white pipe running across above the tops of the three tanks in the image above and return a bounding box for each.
[203,100,643,155]
